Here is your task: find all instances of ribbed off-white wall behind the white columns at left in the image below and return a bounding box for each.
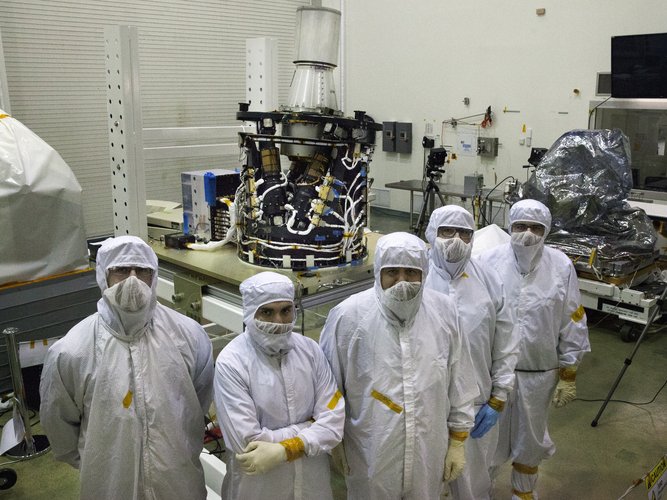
[0,0,308,236]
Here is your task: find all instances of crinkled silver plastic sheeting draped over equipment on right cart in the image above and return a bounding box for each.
[519,130,657,274]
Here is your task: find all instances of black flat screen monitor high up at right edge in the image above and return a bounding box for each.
[611,33,667,99]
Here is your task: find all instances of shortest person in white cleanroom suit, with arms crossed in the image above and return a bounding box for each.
[215,272,345,500]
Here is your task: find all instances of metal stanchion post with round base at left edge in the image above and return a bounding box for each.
[2,328,50,460]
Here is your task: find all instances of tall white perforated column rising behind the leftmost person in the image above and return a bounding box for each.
[104,26,148,239]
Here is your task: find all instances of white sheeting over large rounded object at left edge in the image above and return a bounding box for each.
[0,110,88,286]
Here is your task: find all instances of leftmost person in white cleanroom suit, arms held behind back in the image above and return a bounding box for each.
[40,236,213,499]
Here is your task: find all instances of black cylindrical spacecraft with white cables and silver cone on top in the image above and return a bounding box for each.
[235,6,382,270]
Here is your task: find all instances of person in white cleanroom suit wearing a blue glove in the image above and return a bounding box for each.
[424,205,519,500]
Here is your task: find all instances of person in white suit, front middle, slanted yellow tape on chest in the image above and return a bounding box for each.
[320,233,478,500]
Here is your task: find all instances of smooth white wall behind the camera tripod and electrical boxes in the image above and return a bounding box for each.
[342,0,667,211]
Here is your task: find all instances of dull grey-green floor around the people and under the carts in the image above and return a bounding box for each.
[0,206,667,500]
